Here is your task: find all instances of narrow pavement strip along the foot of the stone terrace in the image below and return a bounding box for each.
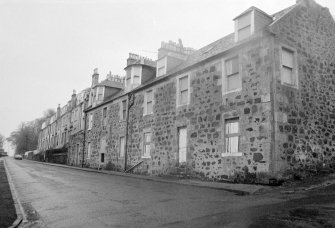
[27,160,273,195]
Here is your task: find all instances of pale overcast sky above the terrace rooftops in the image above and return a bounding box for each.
[0,0,335,155]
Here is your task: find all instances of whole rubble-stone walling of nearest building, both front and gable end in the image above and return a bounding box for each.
[80,0,335,182]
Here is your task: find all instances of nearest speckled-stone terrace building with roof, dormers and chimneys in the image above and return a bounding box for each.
[40,0,335,182]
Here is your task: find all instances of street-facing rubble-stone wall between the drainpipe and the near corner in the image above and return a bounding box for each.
[124,35,273,182]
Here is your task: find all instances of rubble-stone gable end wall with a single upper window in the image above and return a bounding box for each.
[272,1,335,173]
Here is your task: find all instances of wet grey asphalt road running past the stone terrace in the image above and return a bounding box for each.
[7,158,283,227]
